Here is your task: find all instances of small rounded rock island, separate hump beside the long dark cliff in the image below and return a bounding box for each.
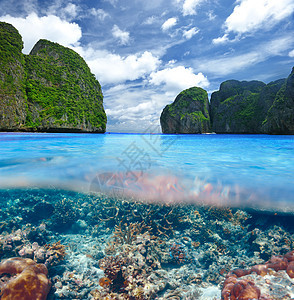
[160,87,210,133]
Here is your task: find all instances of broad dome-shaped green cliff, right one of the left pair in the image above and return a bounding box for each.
[26,40,106,131]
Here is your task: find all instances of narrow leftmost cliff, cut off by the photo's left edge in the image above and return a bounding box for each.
[0,22,26,130]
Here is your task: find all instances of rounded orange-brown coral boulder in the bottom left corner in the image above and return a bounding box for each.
[0,257,51,300]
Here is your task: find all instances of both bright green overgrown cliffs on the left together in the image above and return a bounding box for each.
[0,22,106,133]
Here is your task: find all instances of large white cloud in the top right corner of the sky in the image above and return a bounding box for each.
[224,0,294,34]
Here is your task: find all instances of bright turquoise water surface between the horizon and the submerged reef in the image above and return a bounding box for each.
[0,133,294,211]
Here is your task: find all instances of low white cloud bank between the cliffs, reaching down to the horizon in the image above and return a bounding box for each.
[104,66,209,132]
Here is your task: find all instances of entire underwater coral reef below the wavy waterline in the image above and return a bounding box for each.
[0,189,294,300]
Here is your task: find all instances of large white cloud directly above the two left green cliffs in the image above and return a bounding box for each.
[0,13,82,53]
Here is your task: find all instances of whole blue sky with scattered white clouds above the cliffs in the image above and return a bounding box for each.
[0,0,294,132]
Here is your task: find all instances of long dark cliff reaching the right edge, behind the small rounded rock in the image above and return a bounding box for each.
[210,70,294,134]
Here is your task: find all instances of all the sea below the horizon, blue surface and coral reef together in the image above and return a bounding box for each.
[0,134,294,300]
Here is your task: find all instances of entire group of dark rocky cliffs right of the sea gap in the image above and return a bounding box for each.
[160,68,294,134]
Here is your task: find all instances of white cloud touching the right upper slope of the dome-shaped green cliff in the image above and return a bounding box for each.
[81,50,160,84]
